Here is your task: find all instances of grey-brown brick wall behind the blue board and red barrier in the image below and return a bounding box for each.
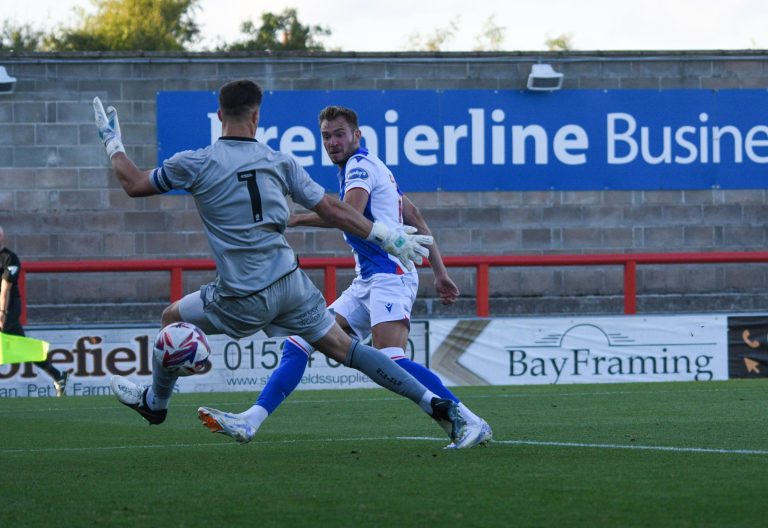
[0,51,768,323]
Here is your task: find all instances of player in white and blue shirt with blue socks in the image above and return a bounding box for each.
[231,106,492,447]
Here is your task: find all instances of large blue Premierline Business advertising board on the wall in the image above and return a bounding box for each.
[157,90,768,192]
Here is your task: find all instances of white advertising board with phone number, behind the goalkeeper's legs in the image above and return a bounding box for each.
[0,321,428,398]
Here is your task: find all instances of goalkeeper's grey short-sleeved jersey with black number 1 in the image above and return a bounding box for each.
[150,137,324,296]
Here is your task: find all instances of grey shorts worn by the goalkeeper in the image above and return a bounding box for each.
[179,269,335,343]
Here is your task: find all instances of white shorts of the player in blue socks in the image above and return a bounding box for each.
[329,273,419,341]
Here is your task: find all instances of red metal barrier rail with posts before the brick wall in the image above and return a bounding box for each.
[19,251,768,323]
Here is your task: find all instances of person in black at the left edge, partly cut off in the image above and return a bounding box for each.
[0,227,69,398]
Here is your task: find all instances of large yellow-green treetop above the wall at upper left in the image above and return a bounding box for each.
[45,0,200,51]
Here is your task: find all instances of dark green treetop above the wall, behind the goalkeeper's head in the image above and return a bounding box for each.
[221,8,331,51]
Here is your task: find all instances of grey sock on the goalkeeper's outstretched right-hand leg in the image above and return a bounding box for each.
[344,339,427,405]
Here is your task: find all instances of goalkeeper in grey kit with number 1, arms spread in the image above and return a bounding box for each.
[93,80,483,448]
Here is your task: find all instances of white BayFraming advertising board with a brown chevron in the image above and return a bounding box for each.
[430,315,728,385]
